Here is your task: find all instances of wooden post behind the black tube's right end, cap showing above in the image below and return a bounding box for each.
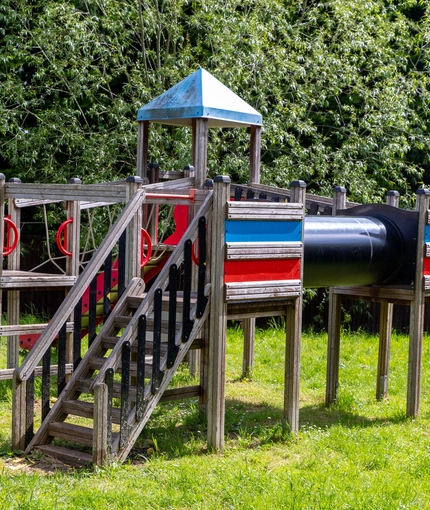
[376,191,400,400]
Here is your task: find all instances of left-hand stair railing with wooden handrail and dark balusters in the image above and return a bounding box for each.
[12,183,145,449]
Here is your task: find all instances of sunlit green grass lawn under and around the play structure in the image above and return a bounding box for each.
[0,328,430,510]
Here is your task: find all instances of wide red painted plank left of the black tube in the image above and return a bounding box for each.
[224,259,300,283]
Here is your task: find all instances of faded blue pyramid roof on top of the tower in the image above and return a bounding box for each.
[137,69,262,127]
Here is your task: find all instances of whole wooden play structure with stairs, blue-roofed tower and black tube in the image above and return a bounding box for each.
[0,69,430,466]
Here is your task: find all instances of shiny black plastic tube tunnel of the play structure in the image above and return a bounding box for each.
[303,204,418,288]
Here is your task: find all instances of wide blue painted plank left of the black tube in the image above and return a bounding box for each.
[225,220,302,243]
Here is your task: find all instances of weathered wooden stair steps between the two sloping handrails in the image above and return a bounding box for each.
[27,270,208,467]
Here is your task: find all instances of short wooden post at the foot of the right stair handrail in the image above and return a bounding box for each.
[93,383,109,466]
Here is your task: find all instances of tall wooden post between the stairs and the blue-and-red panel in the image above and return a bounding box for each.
[208,175,231,450]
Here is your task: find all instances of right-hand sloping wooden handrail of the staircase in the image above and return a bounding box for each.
[91,191,213,388]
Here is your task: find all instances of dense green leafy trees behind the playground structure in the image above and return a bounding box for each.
[0,0,430,201]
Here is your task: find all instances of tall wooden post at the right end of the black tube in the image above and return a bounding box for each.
[406,188,430,417]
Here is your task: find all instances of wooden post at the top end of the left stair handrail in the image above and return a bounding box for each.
[125,176,142,285]
